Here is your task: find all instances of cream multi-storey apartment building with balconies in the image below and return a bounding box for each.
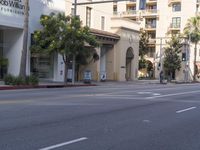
[113,0,200,81]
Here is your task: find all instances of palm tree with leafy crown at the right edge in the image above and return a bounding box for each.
[184,16,200,81]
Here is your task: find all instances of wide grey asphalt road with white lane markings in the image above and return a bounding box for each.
[0,83,200,150]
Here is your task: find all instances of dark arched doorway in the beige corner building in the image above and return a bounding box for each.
[126,47,134,81]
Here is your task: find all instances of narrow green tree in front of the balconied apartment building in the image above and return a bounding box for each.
[164,35,183,81]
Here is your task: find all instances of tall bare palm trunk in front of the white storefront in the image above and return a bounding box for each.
[19,0,29,78]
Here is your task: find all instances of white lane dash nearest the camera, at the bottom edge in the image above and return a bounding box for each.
[39,137,88,150]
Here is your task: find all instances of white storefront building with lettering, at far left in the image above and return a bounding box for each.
[0,0,65,79]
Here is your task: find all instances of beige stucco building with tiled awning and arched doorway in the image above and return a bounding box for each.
[66,0,139,81]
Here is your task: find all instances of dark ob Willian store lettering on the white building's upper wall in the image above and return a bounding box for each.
[0,0,25,16]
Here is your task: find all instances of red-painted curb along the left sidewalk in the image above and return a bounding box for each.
[0,84,97,90]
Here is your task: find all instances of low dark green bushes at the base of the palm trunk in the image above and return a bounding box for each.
[4,75,39,85]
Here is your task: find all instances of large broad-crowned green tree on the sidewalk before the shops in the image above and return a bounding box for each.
[31,13,98,83]
